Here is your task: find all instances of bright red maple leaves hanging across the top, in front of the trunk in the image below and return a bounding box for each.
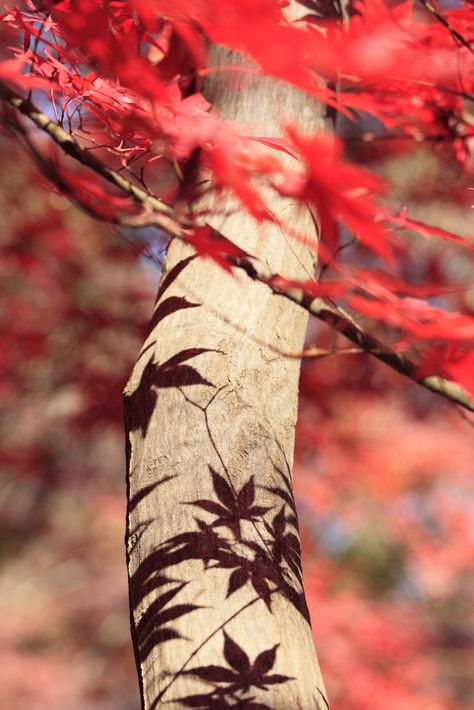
[0,0,474,391]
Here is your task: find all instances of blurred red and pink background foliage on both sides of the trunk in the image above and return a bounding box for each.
[0,126,474,710]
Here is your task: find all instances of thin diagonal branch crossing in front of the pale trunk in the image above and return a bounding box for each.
[0,78,474,412]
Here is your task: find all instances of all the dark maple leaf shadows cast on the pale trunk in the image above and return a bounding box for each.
[125,258,320,710]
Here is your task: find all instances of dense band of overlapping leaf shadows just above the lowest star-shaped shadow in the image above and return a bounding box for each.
[129,466,309,676]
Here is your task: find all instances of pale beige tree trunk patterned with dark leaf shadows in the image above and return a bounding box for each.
[125,13,327,710]
